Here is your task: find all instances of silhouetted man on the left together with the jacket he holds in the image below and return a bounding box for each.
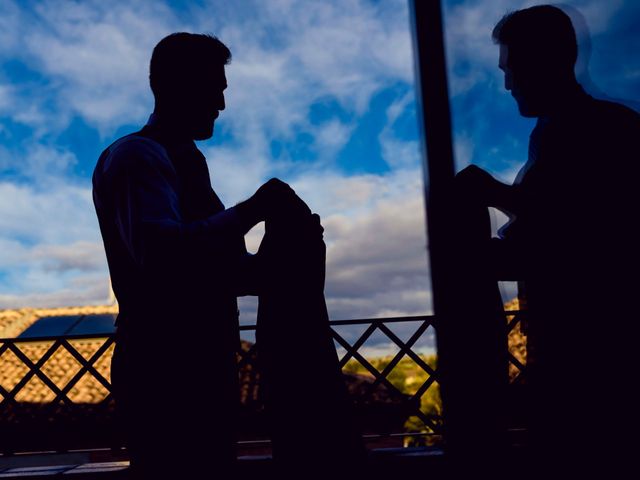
[93,33,363,478]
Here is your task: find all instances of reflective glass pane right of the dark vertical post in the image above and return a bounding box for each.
[442,0,640,442]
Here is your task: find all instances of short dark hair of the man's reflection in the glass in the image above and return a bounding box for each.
[491,5,578,69]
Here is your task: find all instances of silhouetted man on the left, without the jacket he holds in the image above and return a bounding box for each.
[93,33,324,478]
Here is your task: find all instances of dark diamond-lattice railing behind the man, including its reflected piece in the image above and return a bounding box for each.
[0,311,526,454]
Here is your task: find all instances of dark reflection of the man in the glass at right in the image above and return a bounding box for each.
[456,6,640,476]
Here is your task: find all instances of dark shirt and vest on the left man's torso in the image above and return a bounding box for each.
[93,115,247,334]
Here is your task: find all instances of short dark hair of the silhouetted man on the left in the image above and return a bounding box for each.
[149,32,231,98]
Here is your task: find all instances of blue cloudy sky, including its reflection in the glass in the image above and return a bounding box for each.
[0,0,640,346]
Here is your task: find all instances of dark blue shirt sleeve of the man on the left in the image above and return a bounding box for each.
[104,139,243,266]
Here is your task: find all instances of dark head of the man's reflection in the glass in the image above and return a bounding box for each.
[492,5,578,117]
